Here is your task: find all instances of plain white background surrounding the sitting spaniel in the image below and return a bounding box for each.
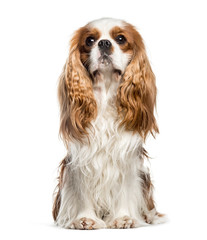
[0,0,207,240]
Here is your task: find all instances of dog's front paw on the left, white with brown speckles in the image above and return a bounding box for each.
[69,217,106,230]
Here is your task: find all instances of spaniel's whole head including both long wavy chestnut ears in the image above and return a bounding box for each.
[59,19,158,141]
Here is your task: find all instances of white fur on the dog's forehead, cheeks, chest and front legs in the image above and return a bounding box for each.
[57,19,165,228]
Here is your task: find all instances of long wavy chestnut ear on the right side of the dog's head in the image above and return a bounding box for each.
[117,26,159,139]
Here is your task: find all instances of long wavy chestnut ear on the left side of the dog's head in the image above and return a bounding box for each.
[58,28,97,145]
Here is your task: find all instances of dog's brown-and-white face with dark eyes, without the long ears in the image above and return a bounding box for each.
[77,19,136,76]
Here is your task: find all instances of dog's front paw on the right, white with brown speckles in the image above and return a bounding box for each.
[108,216,139,228]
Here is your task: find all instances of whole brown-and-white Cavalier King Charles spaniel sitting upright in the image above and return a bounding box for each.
[53,18,164,229]
